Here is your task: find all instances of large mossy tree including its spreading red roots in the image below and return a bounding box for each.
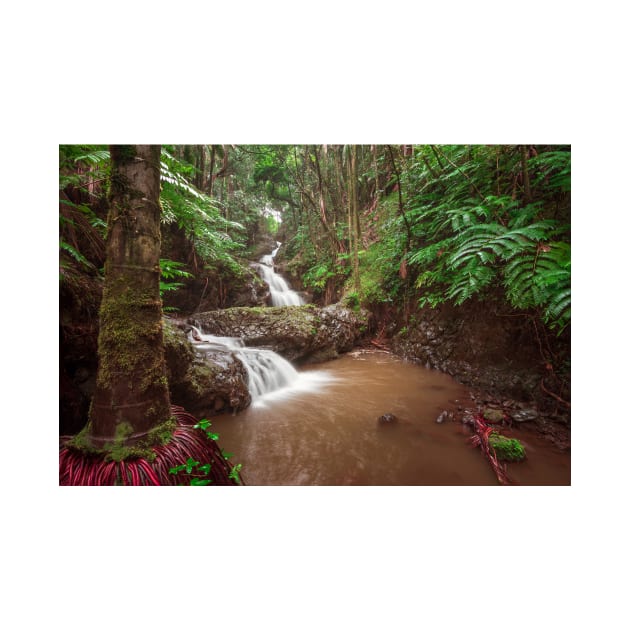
[59,145,234,485]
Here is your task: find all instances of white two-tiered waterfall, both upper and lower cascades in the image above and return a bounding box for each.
[189,243,332,407]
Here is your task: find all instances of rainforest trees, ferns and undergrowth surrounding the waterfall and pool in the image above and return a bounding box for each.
[59,144,571,485]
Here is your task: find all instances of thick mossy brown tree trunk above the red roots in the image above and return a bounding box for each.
[85,145,171,449]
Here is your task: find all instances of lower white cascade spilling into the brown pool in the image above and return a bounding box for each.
[189,326,334,407]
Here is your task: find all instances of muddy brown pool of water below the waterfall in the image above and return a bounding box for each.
[212,350,571,486]
